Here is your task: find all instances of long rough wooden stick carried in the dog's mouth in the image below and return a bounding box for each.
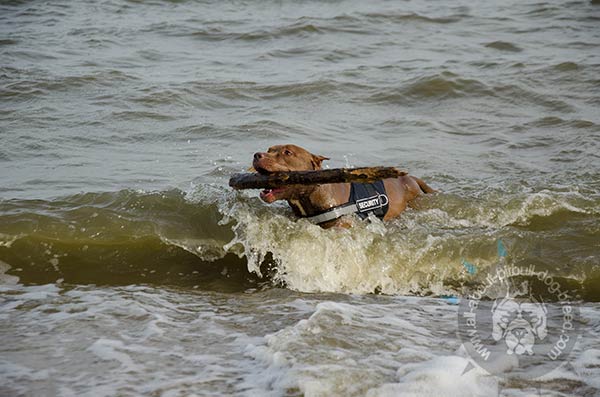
[229,167,406,189]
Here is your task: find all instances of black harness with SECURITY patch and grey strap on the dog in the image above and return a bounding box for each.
[308,181,390,224]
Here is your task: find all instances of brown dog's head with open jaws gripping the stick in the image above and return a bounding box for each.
[252,145,329,203]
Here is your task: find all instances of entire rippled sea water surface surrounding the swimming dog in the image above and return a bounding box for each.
[0,1,600,396]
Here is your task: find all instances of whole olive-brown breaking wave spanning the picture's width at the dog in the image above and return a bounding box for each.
[0,185,600,296]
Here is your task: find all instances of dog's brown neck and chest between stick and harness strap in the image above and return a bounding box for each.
[287,183,350,217]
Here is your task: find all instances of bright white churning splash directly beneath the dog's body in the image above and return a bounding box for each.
[225,198,454,293]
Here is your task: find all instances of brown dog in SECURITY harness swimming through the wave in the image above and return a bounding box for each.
[252,145,435,227]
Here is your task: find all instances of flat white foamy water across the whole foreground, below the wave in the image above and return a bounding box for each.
[0,286,600,397]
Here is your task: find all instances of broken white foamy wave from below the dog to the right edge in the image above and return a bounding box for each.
[220,182,599,295]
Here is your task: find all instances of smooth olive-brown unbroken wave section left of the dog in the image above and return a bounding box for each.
[0,190,257,288]
